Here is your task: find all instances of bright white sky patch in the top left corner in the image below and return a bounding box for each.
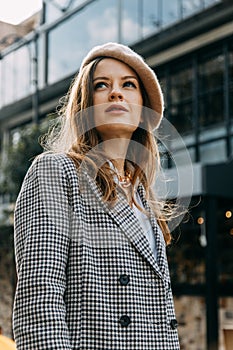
[0,0,42,24]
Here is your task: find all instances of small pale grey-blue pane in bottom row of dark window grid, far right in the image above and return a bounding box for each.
[200,140,226,164]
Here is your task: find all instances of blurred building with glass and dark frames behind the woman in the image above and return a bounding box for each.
[0,0,233,350]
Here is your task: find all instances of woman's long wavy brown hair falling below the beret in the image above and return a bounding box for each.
[43,57,171,244]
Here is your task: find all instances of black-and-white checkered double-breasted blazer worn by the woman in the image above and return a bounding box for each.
[13,154,180,350]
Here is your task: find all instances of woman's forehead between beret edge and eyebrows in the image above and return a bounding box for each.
[94,57,137,78]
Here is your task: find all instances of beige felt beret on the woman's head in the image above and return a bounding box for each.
[80,42,164,128]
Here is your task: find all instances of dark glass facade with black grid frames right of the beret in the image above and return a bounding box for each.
[157,38,233,164]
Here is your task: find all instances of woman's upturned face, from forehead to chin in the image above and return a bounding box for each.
[93,58,143,140]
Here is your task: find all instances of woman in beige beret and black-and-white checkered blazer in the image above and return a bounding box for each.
[13,43,179,350]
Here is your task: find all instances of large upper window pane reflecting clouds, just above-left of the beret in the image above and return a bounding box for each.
[48,0,117,83]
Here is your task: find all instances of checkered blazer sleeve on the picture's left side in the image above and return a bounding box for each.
[13,155,71,350]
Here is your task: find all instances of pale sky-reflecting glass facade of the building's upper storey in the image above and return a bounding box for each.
[0,0,220,110]
